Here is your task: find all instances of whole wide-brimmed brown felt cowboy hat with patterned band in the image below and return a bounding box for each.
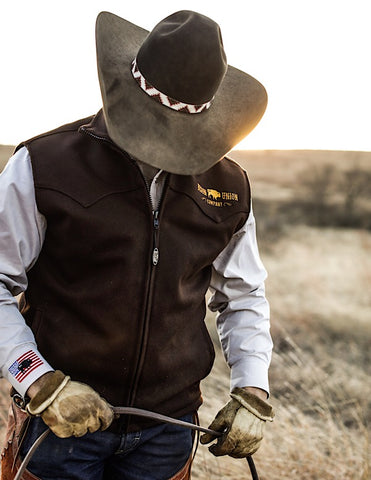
[96,10,267,175]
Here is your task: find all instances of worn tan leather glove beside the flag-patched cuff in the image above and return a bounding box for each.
[26,370,113,438]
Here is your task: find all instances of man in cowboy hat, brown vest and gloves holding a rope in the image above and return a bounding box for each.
[0,11,273,480]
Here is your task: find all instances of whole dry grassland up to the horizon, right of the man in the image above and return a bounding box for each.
[0,149,371,480]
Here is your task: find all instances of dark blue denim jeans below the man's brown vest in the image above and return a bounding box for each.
[21,415,192,480]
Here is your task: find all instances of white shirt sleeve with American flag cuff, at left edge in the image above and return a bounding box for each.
[0,147,53,396]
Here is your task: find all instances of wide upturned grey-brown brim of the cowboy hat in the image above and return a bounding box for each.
[96,12,267,175]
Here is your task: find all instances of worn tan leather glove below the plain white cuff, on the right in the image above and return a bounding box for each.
[200,388,274,458]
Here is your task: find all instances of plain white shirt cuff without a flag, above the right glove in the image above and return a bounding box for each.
[231,357,269,396]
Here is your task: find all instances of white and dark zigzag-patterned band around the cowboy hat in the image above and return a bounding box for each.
[131,58,212,113]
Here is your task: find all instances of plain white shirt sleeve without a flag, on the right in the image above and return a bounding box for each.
[209,209,273,394]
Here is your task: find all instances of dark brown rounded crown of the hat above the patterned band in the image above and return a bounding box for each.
[137,10,227,105]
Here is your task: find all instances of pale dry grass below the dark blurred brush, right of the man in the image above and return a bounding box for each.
[194,226,371,480]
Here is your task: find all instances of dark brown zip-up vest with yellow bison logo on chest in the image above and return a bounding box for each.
[16,112,250,428]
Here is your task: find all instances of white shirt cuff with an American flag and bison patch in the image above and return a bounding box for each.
[3,345,54,397]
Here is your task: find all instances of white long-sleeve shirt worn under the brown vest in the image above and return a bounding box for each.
[0,147,272,395]
